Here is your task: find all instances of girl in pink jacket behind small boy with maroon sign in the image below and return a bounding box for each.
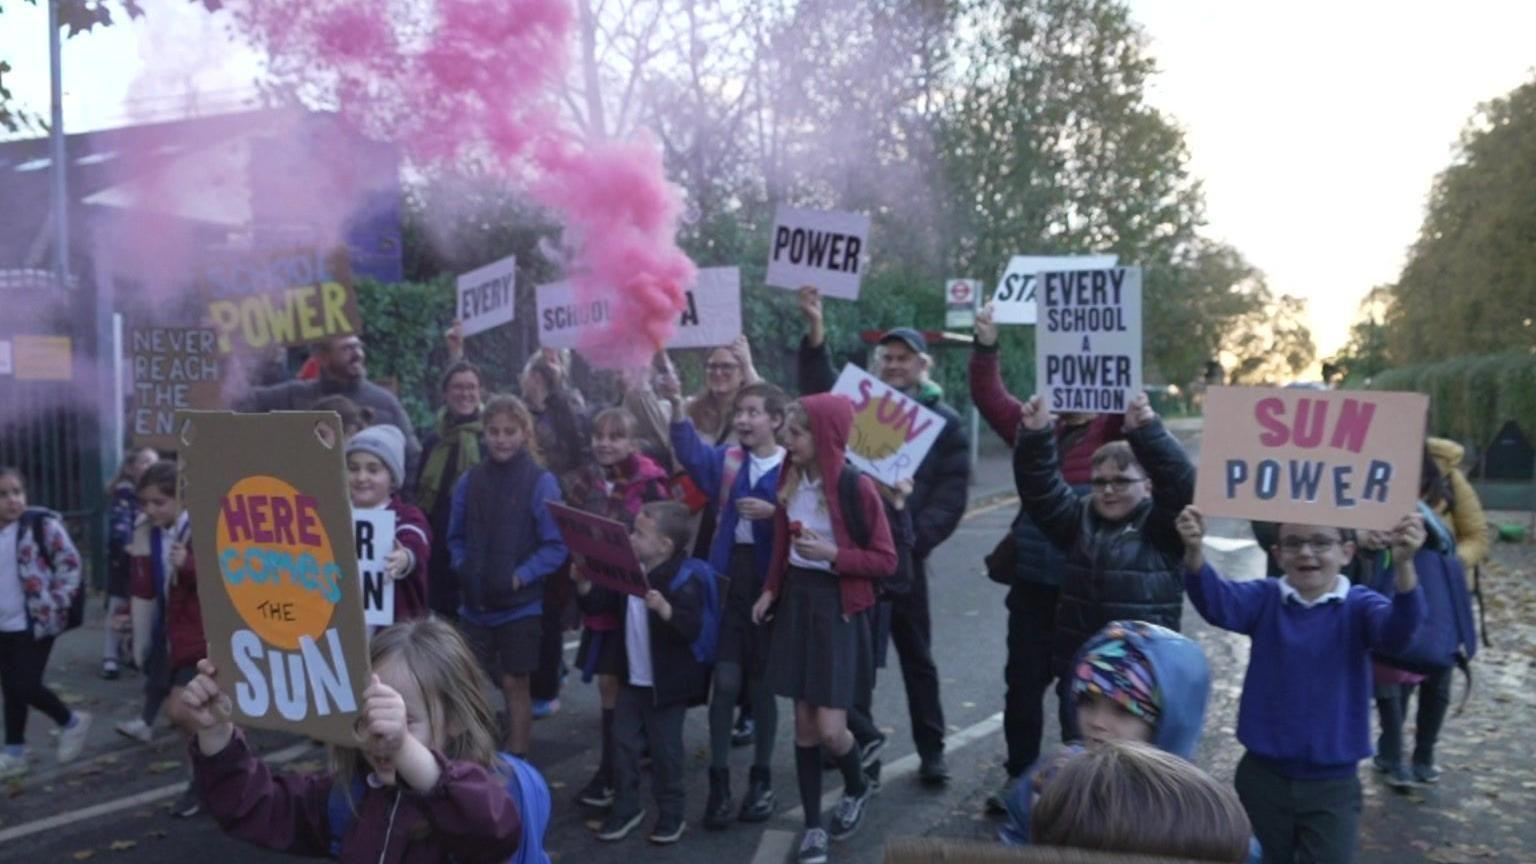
[573,407,670,809]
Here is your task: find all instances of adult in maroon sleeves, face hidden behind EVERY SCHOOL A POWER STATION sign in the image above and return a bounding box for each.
[971,304,1124,813]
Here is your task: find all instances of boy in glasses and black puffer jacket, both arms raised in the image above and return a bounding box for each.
[1014,394,1195,739]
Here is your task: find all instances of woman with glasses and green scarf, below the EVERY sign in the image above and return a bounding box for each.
[412,360,485,620]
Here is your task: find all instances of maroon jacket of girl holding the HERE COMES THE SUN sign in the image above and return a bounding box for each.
[192,730,522,864]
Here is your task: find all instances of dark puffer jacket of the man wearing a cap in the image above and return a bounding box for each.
[797,338,971,561]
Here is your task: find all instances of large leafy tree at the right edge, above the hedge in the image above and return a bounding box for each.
[1385,80,1536,364]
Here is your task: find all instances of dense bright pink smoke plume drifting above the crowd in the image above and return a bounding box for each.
[228,0,694,367]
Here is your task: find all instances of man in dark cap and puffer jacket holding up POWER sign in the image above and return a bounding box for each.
[799,287,971,786]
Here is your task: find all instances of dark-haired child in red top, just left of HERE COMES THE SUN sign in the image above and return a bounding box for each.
[115,461,207,818]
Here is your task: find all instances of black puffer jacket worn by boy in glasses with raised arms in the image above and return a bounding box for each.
[1014,421,1195,675]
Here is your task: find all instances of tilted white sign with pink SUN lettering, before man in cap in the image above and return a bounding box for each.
[833,363,945,486]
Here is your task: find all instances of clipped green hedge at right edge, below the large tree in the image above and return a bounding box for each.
[1367,349,1536,450]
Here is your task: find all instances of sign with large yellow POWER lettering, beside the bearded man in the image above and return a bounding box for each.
[203,249,362,354]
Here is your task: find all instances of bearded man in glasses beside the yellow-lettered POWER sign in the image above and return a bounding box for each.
[235,335,421,477]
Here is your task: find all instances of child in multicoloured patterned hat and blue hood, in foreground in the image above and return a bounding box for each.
[998,621,1210,846]
